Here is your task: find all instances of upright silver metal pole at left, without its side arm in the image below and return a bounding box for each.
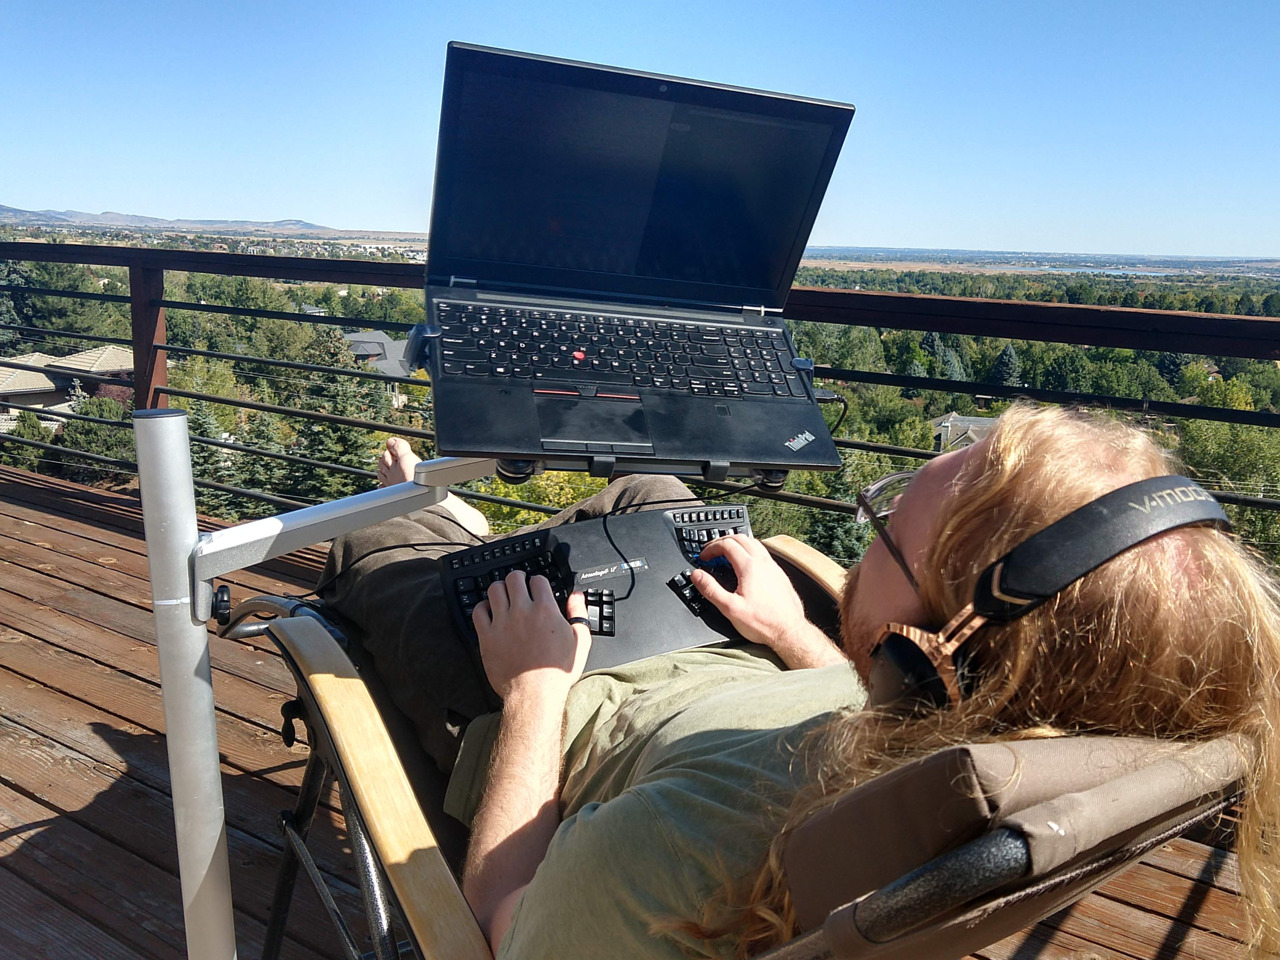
[133,410,236,960]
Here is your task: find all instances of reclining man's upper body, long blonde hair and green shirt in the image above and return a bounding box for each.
[320,406,1280,960]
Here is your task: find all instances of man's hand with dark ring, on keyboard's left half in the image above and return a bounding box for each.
[471,570,591,700]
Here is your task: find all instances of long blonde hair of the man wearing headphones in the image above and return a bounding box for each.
[701,406,1280,957]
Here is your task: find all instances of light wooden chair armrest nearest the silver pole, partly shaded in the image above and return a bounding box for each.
[270,617,492,960]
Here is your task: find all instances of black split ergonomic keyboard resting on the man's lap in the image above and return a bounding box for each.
[442,503,751,669]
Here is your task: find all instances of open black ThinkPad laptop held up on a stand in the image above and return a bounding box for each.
[424,42,854,484]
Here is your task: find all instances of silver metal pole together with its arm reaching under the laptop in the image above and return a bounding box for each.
[133,410,495,960]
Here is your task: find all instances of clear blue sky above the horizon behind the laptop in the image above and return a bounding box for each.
[0,0,1280,257]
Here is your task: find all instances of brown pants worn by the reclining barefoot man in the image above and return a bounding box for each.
[317,475,692,771]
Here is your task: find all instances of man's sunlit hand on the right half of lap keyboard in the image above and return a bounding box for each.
[692,534,846,669]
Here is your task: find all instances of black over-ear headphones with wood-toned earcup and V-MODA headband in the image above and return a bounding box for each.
[869,476,1231,709]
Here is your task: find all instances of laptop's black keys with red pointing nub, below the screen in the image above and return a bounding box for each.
[435,301,805,398]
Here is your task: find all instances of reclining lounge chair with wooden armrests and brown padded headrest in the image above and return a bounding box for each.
[228,538,1247,960]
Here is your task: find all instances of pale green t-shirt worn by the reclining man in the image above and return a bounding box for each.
[497,646,865,960]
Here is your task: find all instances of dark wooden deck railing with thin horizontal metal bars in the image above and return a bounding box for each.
[0,236,1280,529]
